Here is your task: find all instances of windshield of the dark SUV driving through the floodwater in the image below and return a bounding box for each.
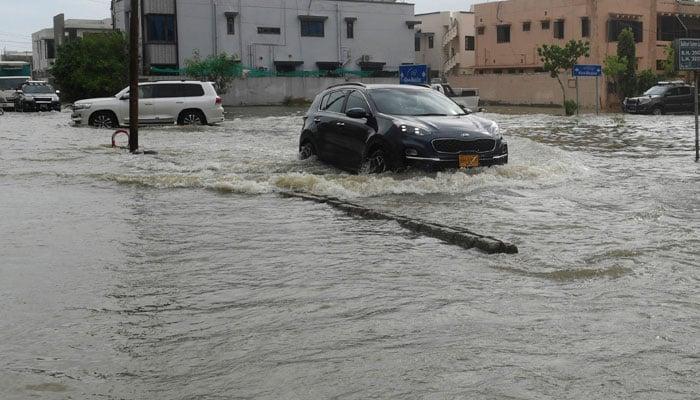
[368,88,465,116]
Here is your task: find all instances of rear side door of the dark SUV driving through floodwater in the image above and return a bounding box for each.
[314,90,347,165]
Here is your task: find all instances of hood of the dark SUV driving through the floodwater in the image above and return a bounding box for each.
[397,114,498,139]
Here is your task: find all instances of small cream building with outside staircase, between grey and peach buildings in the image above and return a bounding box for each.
[415,11,476,76]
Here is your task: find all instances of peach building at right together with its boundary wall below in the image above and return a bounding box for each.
[453,0,700,107]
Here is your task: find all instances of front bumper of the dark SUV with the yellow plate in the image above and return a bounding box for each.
[404,140,508,169]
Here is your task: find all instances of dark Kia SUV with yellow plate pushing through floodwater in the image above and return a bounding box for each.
[299,83,508,173]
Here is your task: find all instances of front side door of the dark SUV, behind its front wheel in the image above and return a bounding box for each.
[338,90,375,168]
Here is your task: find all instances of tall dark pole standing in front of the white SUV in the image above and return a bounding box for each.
[129,0,140,153]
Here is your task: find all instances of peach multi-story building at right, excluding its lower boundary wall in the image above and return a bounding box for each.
[474,0,700,74]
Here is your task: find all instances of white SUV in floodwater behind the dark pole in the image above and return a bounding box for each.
[71,81,224,128]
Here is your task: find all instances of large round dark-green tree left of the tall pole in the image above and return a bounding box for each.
[51,32,129,102]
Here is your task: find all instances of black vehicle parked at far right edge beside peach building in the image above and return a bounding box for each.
[622,81,695,115]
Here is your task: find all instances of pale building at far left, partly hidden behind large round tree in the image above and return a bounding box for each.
[32,14,114,78]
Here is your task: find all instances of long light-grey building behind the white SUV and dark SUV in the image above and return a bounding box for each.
[112,0,417,73]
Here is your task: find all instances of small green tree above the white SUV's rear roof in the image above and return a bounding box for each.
[184,50,243,94]
